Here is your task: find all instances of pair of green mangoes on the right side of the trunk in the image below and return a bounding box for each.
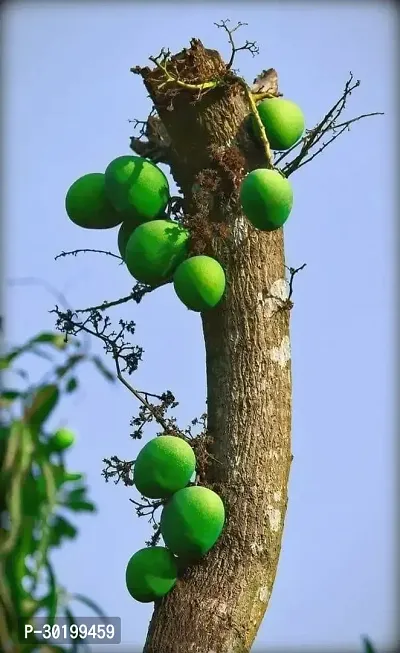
[240,98,305,231]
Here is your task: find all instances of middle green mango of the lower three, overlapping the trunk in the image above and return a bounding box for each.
[160,486,225,562]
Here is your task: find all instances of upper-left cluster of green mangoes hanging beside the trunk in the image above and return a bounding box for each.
[65,156,225,312]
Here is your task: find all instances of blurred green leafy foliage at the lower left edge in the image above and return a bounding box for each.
[0,332,110,653]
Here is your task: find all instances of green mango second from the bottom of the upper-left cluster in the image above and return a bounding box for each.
[125,220,189,286]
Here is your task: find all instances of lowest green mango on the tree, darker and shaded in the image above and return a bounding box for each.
[125,546,178,603]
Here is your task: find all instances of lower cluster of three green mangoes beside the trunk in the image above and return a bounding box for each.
[125,435,225,603]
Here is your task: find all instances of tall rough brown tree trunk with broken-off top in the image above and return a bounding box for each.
[136,40,292,653]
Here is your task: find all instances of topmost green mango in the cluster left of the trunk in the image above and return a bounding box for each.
[104,156,169,222]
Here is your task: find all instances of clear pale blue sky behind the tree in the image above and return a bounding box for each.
[3,2,397,652]
